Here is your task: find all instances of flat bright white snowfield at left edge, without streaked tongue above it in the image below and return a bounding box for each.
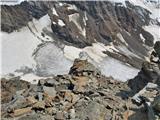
[0,28,40,74]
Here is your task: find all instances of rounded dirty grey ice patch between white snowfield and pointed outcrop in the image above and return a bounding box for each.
[35,43,72,76]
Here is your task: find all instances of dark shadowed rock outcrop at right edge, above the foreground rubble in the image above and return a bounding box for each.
[128,41,160,92]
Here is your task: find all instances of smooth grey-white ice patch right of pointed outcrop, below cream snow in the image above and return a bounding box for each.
[99,57,139,82]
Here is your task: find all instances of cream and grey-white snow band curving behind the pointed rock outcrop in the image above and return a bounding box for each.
[64,43,139,81]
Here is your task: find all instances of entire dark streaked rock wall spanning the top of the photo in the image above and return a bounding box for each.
[1,1,153,49]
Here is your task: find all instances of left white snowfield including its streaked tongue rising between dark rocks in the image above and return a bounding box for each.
[0,15,52,75]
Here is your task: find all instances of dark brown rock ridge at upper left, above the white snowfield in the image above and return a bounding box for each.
[1,2,53,33]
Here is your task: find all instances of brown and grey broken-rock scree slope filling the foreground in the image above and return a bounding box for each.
[1,42,160,120]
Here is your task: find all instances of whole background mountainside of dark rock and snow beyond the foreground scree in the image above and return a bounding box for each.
[1,0,159,81]
